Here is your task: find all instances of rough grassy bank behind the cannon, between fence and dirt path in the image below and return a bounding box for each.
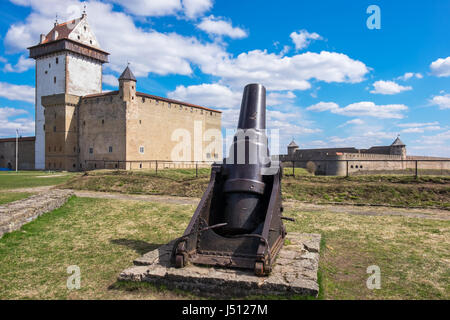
[65,168,450,209]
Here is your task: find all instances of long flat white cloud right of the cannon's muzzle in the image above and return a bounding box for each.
[306,101,408,119]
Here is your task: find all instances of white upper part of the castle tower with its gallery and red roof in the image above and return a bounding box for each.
[28,13,109,169]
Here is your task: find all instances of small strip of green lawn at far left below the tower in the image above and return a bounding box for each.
[0,171,77,190]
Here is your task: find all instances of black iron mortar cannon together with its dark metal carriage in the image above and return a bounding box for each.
[172,84,287,275]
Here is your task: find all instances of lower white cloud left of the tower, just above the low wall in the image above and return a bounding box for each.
[0,107,34,137]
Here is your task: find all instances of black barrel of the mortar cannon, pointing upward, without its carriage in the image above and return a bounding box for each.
[223,84,269,235]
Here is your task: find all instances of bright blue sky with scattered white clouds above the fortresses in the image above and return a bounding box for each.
[0,0,450,157]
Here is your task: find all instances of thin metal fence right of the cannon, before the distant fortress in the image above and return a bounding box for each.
[282,159,450,177]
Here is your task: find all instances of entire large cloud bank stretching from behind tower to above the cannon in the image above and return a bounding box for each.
[5,0,369,91]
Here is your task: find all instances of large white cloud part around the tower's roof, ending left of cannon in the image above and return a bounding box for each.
[5,0,228,76]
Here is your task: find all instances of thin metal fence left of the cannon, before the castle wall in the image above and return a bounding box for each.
[82,160,214,177]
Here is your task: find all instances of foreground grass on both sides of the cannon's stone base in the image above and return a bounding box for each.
[0,197,450,299]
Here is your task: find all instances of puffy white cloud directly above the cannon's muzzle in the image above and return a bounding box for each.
[207,50,369,91]
